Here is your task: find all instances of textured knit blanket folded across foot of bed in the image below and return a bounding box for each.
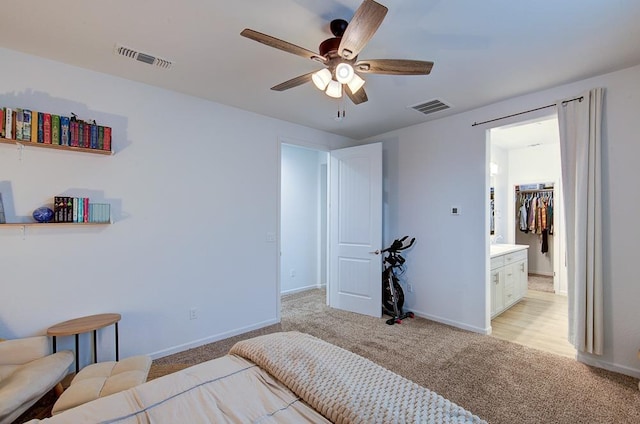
[229,332,485,424]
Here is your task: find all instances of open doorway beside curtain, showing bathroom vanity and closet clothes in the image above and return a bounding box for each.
[489,115,575,357]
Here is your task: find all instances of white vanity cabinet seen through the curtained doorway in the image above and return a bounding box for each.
[490,248,528,318]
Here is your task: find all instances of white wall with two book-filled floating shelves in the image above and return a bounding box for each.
[0,49,348,359]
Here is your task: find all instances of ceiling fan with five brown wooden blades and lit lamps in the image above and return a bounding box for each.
[240,0,433,104]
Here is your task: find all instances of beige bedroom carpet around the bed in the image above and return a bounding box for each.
[17,290,640,424]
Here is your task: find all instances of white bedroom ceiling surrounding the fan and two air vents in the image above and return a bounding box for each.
[0,0,640,139]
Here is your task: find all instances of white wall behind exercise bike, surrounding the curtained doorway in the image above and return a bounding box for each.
[363,66,640,377]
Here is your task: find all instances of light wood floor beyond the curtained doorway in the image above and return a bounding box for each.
[491,290,576,358]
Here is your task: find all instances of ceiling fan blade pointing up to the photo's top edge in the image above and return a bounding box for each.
[338,0,388,59]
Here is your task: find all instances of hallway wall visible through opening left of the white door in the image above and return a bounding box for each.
[280,144,327,293]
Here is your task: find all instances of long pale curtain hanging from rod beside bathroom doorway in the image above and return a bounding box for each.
[557,88,604,355]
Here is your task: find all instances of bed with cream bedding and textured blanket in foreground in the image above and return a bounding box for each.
[23,332,485,424]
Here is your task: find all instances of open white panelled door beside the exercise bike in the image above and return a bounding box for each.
[327,143,382,317]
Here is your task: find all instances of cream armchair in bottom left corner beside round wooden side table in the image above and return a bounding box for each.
[0,336,73,424]
